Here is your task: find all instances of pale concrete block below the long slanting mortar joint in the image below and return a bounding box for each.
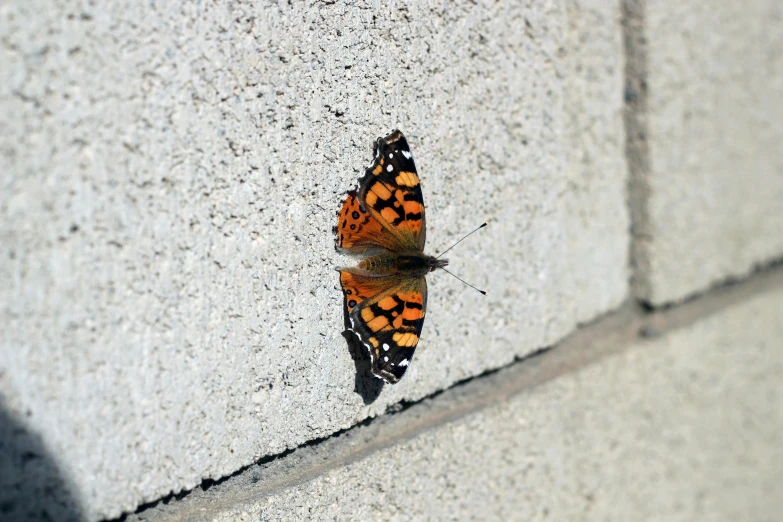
[191,286,783,522]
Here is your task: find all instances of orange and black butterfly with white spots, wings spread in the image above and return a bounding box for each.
[334,130,448,384]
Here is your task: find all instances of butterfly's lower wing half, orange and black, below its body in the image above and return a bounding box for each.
[340,269,427,384]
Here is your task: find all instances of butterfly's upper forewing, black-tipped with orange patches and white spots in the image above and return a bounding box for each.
[359,130,426,251]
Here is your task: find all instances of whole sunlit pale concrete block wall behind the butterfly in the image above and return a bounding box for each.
[0,0,783,520]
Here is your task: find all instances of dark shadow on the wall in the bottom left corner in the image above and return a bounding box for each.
[0,396,84,522]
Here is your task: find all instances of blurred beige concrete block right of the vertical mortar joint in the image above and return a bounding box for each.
[626,0,783,305]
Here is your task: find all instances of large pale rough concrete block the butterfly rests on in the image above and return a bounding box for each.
[0,0,626,519]
